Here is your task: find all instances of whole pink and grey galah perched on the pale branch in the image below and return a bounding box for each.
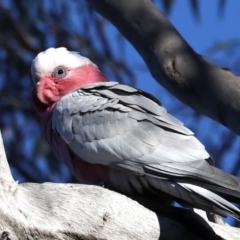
[31,47,240,220]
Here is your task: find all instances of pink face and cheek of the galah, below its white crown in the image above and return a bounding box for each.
[32,64,108,112]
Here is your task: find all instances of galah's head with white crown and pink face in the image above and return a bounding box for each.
[31,47,108,112]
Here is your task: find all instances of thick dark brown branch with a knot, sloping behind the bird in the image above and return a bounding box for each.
[86,0,240,134]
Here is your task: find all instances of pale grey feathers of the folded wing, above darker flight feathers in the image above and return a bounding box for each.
[53,83,209,171]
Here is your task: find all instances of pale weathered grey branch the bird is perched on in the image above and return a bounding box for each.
[0,135,240,240]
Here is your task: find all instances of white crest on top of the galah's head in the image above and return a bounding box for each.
[31,47,97,80]
